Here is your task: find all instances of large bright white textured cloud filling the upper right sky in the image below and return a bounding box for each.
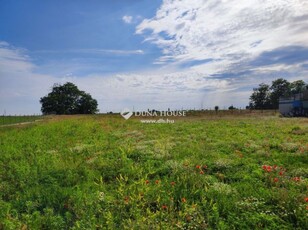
[136,0,308,67]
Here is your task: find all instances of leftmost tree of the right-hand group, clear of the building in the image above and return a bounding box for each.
[250,83,271,109]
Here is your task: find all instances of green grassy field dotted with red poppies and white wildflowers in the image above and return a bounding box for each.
[0,115,308,230]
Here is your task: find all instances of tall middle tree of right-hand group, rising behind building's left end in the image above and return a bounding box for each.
[270,78,291,109]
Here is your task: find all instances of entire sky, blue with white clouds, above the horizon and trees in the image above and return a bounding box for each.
[0,0,308,114]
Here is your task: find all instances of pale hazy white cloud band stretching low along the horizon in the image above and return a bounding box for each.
[0,36,308,114]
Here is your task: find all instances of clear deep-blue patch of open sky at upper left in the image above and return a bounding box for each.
[0,0,159,76]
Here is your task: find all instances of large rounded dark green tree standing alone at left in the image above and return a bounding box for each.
[40,82,98,114]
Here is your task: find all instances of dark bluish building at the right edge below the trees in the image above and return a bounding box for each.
[279,90,308,117]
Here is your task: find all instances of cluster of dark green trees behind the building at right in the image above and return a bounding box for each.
[248,78,308,109]
